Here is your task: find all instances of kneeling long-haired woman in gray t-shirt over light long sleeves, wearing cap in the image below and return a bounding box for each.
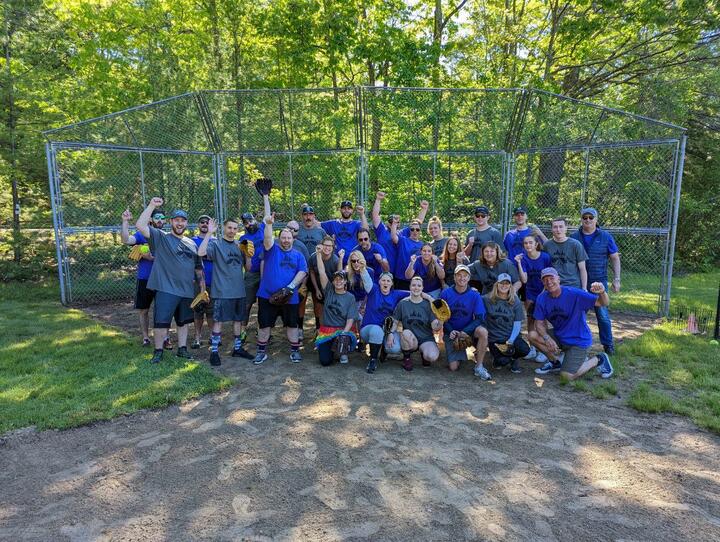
[483,273,530,373]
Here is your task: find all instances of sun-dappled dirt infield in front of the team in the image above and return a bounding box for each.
[0,304,720,541]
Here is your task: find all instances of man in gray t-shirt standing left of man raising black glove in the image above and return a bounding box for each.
[198,218,255,366]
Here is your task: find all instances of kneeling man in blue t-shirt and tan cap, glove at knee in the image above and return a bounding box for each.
[440,264,492,380]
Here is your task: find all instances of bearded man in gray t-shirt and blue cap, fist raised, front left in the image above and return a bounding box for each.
[135,197,205,363]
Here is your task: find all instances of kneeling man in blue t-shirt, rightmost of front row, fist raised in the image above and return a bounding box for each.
[530,267,613,380]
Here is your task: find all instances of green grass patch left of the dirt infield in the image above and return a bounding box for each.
[0,281,232,433]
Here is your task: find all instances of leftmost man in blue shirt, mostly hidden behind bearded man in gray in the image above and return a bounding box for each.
[120,209,165,348]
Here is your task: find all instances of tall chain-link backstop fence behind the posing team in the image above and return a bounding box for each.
[45,87,685,313]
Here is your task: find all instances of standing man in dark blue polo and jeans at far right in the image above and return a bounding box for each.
[570,207,620,356]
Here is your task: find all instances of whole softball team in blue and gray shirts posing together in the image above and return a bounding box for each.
[121,192,620,380]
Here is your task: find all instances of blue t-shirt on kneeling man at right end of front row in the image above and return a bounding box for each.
[533,286,598,348]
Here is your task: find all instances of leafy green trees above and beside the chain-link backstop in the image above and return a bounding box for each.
[0,0,720,272]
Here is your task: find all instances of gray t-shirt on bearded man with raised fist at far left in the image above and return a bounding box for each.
[147,226,202,298]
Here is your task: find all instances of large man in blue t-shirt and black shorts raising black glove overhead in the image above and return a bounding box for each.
[253,210,308,365]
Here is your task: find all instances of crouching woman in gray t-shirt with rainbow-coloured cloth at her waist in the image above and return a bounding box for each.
[315,245,360,367]
